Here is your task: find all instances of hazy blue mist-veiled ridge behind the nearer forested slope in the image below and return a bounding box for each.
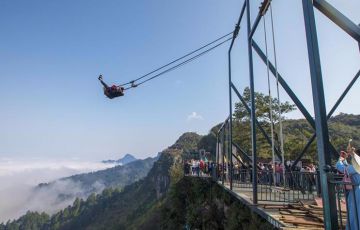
[32,158,157,212]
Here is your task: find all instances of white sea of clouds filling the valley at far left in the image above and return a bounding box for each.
[0,158,115,223]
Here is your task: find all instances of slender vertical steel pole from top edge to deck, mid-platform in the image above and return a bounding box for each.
[246,0,258,204]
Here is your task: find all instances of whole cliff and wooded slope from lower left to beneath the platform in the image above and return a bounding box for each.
[0,131,271,230]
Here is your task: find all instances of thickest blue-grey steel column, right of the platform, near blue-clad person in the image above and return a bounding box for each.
[302,0,338,230]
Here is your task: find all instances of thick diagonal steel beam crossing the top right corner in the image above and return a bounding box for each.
[313,0,360,43]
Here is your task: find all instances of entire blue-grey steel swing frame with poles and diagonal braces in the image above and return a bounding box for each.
[217,0,360,229]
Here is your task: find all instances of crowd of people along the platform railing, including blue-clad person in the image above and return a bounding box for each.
[184,138,360,230]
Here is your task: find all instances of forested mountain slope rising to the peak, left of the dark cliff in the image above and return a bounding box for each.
[0,133,201,230]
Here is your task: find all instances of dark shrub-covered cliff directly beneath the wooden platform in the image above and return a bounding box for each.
[161,177,273,230]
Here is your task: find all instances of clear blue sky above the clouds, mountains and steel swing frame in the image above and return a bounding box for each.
[0,0,360,160]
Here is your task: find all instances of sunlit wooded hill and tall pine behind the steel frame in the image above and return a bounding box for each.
[194,88,360,163]
